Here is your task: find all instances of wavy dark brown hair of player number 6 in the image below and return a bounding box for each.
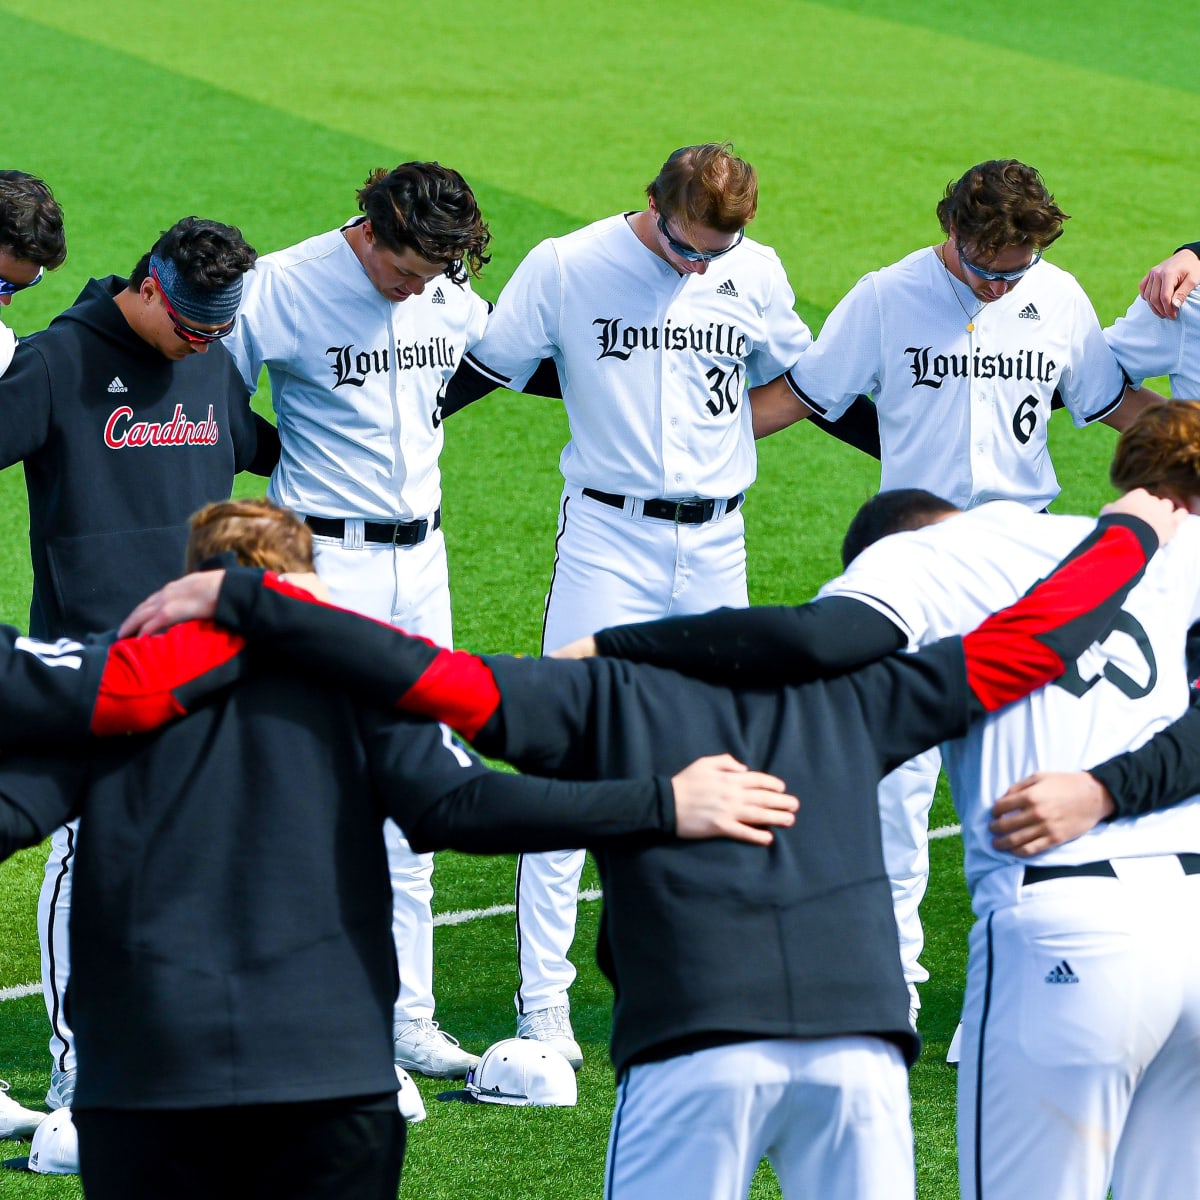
[937,158,1070,258]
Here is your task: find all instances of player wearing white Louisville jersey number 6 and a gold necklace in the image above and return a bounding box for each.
[755,160,1160,1036]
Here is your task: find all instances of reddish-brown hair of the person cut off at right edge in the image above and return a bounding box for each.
[1109,400,1200,503]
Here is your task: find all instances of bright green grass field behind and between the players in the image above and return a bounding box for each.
[0,0,1200,1200]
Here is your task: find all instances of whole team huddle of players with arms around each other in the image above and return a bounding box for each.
[0,152,1200,1200]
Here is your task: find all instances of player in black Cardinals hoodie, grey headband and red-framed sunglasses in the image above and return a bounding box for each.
[0,216,278,1108]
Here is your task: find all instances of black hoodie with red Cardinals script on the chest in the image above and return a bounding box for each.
[0,276,278,637]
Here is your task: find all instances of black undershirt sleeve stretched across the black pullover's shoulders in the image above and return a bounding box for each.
[596,596,905,688]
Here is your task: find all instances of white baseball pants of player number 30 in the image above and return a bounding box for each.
[516,485,749,1013]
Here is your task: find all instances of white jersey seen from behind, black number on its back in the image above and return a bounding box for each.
[821,503,1200,914]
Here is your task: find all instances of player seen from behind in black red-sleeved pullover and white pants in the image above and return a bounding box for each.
[129,484,1182,1200]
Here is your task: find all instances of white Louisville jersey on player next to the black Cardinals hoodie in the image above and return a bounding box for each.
[226,229,487,521]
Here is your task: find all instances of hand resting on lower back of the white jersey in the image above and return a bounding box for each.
[988,770,1116,858]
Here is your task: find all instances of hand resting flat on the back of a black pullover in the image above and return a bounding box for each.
[671,754,800,846]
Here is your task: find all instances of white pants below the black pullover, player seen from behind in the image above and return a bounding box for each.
[605,1036,912,1200]
